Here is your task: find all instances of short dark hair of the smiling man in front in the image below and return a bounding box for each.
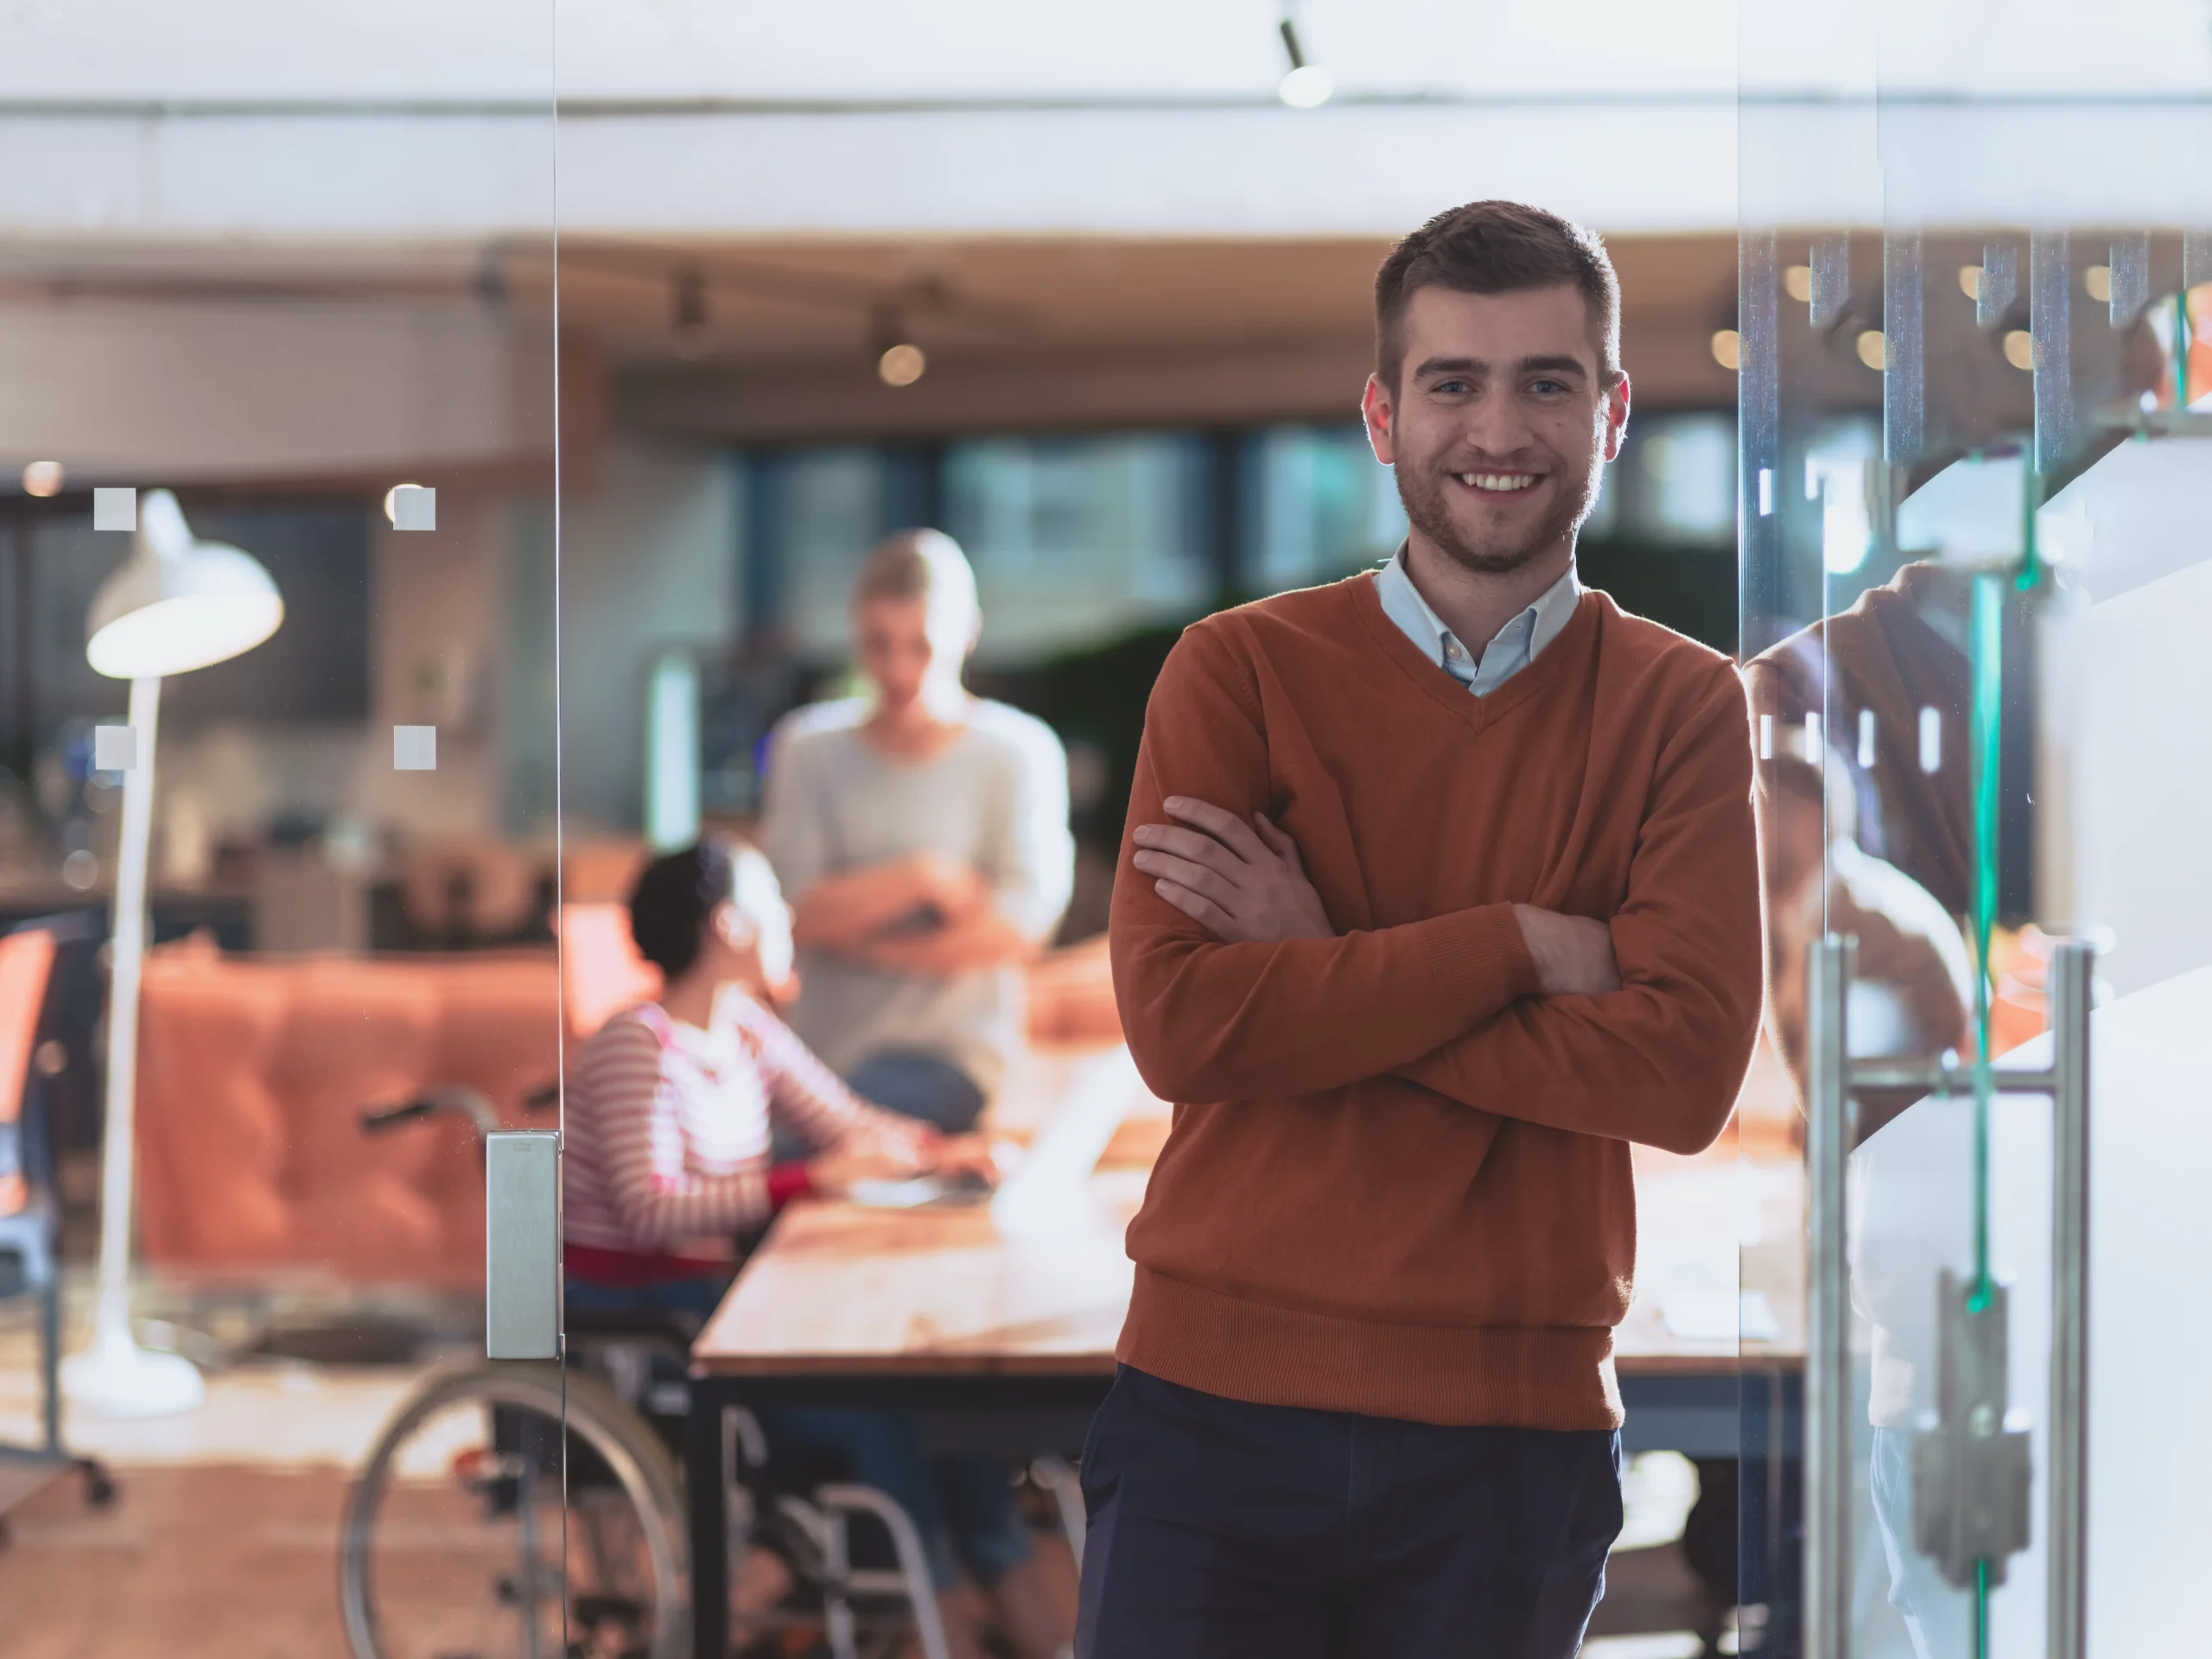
[1376,201,1621,391]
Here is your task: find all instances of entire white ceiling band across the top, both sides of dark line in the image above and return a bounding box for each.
[0,0,2212,244]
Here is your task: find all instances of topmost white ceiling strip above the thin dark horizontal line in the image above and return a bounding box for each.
[0,0,2212,99]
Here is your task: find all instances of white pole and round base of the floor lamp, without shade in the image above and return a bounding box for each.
[62,679,208,1418]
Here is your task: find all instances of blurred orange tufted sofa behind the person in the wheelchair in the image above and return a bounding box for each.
[139,925,1122,1287]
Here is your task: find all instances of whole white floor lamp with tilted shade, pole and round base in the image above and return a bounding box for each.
[62,489,283,1418]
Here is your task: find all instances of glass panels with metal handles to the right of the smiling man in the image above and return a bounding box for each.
[1738,4,2212,1659]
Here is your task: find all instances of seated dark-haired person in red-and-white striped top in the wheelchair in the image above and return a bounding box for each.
[562,841,1058,1659]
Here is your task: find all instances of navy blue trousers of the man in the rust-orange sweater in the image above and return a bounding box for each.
[1075,1365,1621,1659]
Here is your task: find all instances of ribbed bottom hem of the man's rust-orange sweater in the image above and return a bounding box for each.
[1115,1265,1624,1431]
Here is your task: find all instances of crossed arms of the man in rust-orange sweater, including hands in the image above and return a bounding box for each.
[1113,628,1761,1153]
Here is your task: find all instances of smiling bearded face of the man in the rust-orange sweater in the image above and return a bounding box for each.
[1363,283,1628,573]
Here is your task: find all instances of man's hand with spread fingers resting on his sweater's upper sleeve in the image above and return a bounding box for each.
[1135,797,1336,944]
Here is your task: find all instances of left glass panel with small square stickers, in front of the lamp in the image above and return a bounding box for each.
[0,16,588,1659]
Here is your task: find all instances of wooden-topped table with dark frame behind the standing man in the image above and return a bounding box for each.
[686,1052,1805,1659]
